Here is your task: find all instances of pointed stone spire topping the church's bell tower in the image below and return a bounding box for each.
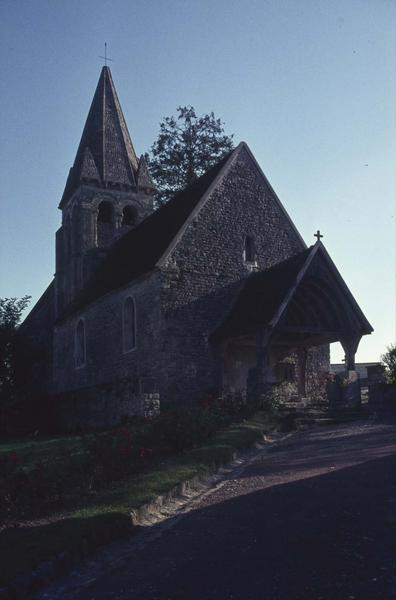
[60,66,138,208]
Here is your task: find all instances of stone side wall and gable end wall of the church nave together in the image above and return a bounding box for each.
[53,148,326,428]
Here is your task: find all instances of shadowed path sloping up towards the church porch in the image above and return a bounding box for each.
[39,422,396,600]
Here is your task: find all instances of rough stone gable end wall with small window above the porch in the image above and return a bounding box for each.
[161,149,304,402]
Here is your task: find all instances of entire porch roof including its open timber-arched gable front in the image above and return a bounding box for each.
[211,241,373,346]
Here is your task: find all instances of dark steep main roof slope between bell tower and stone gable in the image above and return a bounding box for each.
[58,148,232,319]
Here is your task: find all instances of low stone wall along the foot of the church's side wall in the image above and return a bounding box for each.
[54,379,160,432]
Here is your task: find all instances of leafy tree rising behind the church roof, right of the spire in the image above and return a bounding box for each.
[146,106,233,205]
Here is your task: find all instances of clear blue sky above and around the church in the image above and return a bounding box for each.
[0,0,396,361]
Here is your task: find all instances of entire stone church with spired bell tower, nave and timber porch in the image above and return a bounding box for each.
[21,67,372,428]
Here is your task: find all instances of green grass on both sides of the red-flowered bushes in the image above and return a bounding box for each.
[0,412,278,586]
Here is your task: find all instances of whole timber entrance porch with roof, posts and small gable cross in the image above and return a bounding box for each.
[211,241,373,405]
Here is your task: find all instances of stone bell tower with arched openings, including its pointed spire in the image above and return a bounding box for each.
[55,66,155,316]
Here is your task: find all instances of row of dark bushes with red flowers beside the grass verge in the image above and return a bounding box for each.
[0,393,278,522]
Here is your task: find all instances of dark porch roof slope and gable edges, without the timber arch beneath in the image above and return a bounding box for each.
[211,242,373,342]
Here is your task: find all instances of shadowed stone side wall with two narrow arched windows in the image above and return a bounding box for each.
[52,273,160,426]
